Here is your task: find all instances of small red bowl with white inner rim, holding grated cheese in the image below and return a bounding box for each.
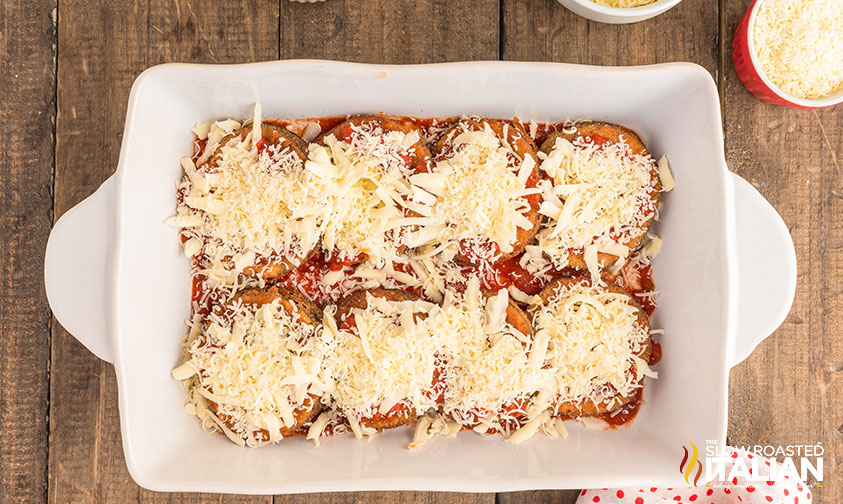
[732,0,843,109]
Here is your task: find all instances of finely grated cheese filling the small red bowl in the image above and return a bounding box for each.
[750,0,843,99]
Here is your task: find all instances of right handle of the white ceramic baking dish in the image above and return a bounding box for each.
[731,174,796,366]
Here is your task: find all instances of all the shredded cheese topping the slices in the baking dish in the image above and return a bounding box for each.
[173,111,674,447]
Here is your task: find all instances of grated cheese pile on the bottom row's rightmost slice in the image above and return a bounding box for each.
[533,284,656,412]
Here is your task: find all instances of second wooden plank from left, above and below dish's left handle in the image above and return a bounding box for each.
[49,0,278,504]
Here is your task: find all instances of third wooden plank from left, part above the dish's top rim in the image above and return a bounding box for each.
[280,0,500,63]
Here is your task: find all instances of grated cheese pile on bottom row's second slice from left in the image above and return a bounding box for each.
[325,293,438,428]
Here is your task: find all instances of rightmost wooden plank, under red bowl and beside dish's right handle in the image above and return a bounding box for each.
[724,0,843,503]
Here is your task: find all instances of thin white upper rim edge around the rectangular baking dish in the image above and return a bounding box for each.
[107,59,738,494]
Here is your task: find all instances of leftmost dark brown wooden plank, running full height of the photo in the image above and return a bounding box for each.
[0,1,56,502]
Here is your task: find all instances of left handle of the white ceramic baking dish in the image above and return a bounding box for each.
[44,176,114,362]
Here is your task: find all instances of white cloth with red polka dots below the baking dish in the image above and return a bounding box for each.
[577,450,812,504]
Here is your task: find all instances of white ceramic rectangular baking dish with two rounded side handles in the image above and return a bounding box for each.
[45,61,796,493]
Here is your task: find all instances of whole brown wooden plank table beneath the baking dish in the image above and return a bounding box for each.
[0,0,843,504]
